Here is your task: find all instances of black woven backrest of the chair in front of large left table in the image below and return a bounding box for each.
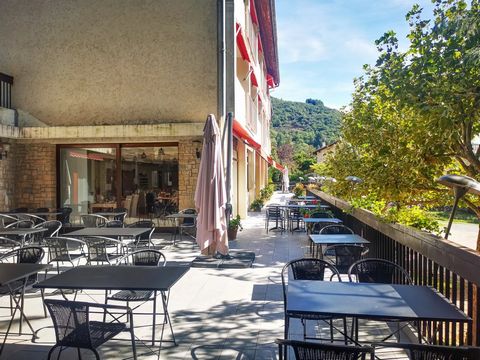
[45,299,92,348]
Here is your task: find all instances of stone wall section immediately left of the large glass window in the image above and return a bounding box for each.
[14,144,57,209]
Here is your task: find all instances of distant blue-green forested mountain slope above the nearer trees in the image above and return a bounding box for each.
[272,97,341,149]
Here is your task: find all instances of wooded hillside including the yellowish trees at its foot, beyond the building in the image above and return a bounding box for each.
[270,97,341,180]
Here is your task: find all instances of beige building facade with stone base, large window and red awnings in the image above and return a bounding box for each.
[0,0,279,216]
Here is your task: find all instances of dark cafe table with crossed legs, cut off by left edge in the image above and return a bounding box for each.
[0,263,50,354]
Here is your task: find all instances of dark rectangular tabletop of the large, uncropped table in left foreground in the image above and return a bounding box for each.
[34,266,189,291]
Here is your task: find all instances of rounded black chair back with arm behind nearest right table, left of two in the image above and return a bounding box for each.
[281,258,342,308]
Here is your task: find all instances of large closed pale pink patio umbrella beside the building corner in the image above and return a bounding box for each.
[195,114,228,255]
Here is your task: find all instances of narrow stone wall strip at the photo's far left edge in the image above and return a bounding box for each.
[0,144,17,211]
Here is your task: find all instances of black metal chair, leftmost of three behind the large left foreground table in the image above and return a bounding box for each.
[43,236,86,274]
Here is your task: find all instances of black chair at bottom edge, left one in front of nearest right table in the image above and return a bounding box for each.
[275,339,375,360]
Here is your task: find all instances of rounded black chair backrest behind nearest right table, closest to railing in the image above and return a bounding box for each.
[348,259,412,284]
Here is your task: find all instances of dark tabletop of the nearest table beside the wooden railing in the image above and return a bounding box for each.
[287,280,471,322]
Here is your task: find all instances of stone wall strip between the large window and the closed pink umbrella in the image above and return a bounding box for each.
[178,141,202,210]
